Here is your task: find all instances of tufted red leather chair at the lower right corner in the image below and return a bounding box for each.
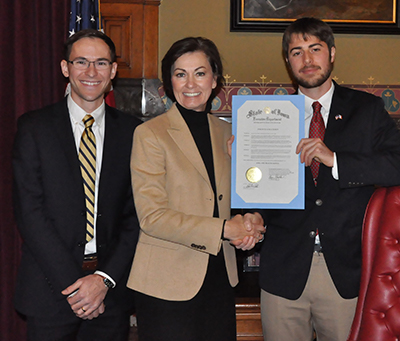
[348,186,400,341]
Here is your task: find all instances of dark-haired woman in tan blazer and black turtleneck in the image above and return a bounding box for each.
[128,38,264,341]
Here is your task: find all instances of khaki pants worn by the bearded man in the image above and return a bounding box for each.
[261,252,357,341]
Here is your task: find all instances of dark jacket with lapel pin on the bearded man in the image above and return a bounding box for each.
[260,84,400,299]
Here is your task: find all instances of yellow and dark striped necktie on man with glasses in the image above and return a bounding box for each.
[79,115,96,242]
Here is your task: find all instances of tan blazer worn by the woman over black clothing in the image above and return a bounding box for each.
[127,106,238,301]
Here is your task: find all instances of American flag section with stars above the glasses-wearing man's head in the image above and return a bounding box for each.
[69,0,102,36]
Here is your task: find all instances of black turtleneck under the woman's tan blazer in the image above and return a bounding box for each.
[176,101,219,217]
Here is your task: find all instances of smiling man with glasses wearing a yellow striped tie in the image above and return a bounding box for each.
[13,30,139,341]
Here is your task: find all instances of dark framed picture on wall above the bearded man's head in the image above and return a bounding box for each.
[231,0,400,34]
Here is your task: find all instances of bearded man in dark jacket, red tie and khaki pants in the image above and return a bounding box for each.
[260,18,400,341]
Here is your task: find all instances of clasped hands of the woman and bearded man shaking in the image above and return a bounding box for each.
[223,212,265,250]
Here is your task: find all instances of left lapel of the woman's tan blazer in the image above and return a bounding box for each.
[167,105,211,186]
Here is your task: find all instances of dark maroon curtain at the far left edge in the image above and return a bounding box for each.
[0,0,70,341]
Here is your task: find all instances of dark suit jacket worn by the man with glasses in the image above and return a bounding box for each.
[13,100,139,316]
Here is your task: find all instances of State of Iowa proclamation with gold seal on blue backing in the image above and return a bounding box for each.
[231,95,304,209]
